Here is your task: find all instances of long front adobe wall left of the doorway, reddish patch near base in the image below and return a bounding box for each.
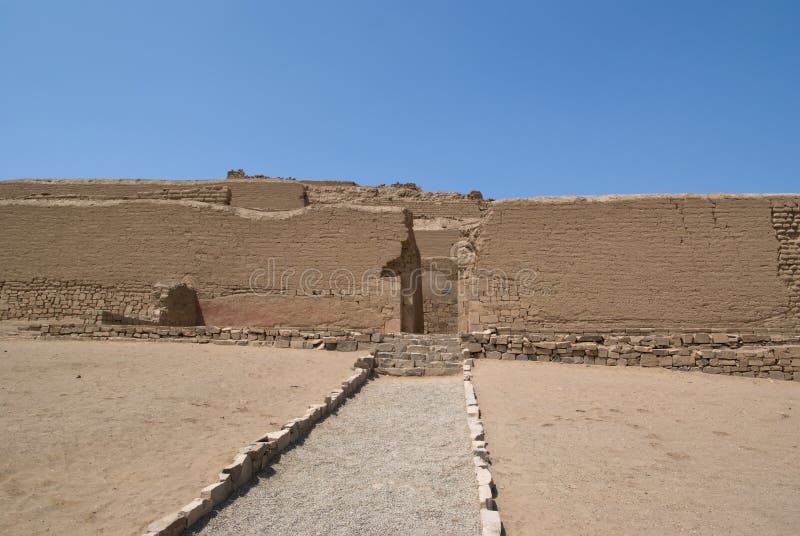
[0,200,421,331]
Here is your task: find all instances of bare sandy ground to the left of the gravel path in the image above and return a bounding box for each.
[0,340,359,535]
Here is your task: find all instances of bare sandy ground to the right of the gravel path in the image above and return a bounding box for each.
[474,361,800,536]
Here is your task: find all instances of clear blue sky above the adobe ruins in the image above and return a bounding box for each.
[0,0,800,198]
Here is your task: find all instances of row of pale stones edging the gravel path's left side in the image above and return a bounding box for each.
[145,356,378,536]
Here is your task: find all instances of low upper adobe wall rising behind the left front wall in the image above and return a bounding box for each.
[0,179,308,211]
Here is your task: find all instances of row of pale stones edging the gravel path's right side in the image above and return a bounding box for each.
[464,359,503,536]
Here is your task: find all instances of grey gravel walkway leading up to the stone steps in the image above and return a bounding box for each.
[191,378,480,536]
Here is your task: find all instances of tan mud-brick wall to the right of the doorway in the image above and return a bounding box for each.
[460,195,800,331]
